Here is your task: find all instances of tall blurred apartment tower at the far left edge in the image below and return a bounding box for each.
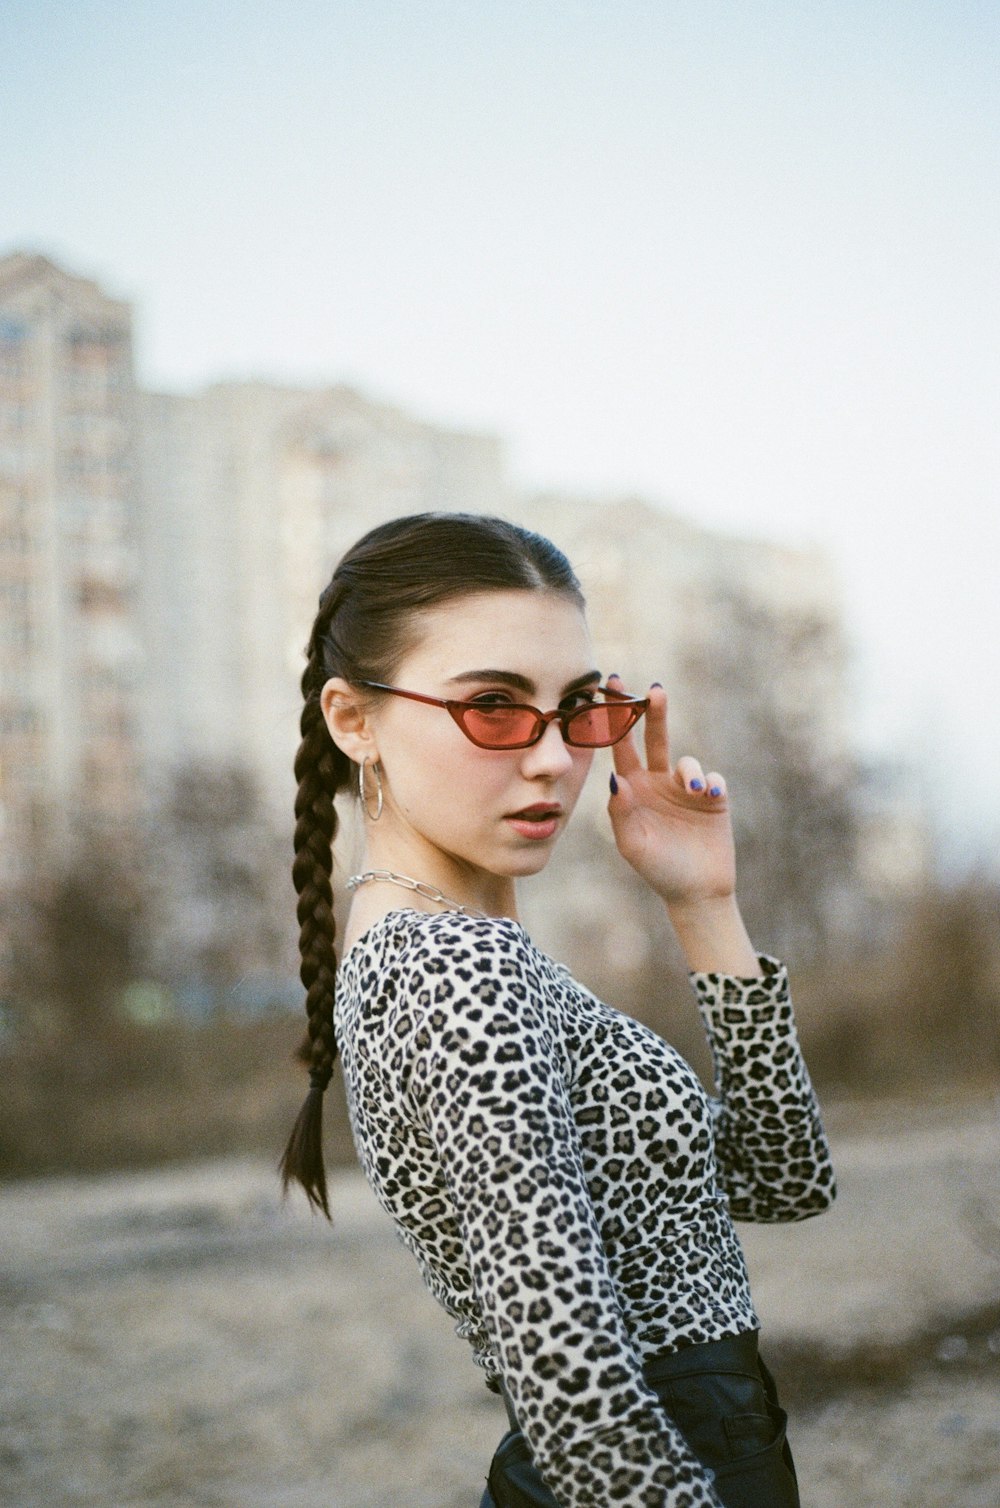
[0,253,142,869]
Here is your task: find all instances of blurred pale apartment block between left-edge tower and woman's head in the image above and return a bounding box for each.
[139,382,508,813]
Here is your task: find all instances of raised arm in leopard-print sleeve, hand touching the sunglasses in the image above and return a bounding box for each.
[608,686,834,1220]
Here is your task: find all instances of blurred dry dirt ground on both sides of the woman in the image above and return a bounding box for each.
[0,1102,1000,1508]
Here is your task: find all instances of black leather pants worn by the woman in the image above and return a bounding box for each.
[480,1330,799,1508]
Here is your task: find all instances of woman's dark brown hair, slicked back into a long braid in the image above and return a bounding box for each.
[281,513,584,1218]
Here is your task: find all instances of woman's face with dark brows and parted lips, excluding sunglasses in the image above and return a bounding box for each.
[360,591,599,903]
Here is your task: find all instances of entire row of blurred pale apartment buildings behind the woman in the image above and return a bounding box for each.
[0,253,926,958]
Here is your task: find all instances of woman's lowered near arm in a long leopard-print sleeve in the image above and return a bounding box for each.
[409,920,718,1508]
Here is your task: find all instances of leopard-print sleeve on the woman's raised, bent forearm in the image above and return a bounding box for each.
[691,956,836,1223]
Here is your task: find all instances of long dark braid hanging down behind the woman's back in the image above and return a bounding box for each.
[281,591,348,1220]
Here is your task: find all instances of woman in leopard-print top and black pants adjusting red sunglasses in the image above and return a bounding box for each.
[282,514,833,1508]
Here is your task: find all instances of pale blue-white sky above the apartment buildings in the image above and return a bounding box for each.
[0,0,1000,863]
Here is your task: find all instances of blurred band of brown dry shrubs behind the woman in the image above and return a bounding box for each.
[0,838,1000,1176]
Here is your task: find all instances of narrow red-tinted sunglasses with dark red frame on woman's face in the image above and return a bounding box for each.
[357,680,649,749]
